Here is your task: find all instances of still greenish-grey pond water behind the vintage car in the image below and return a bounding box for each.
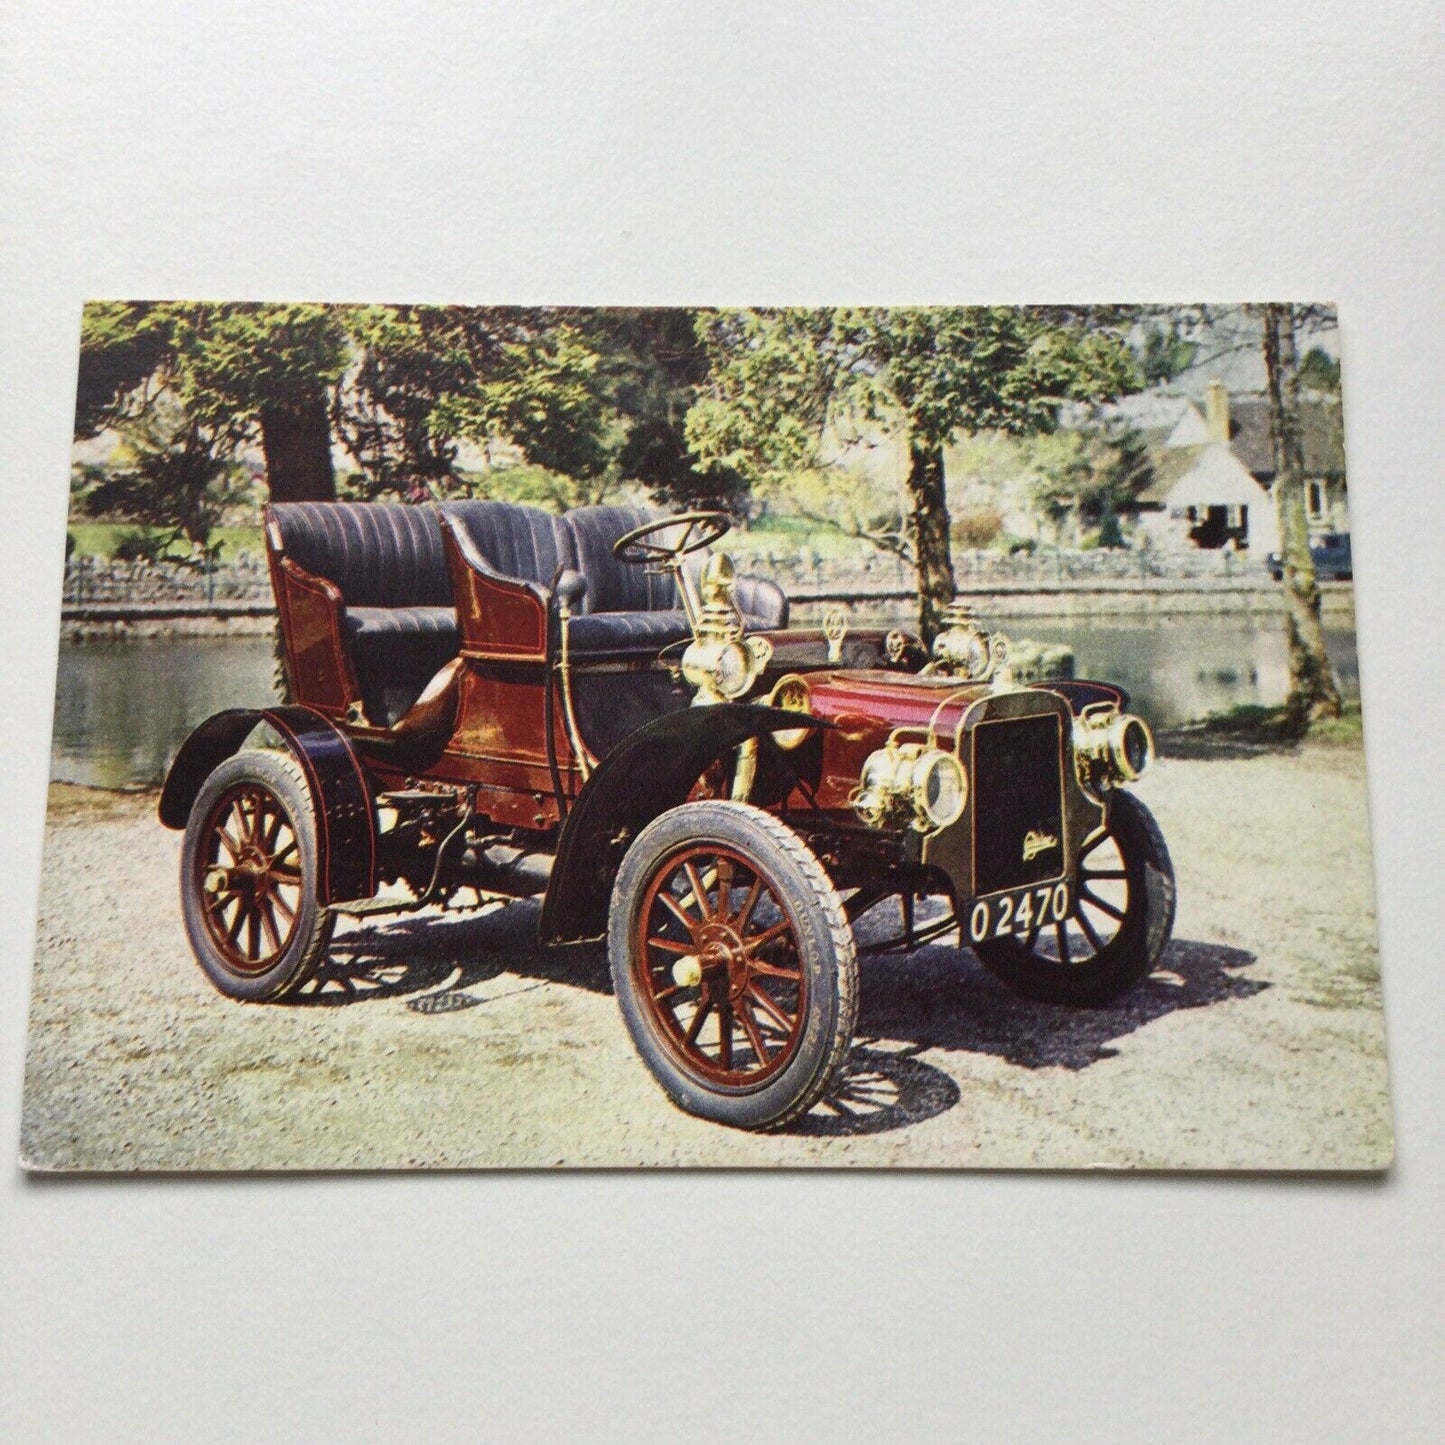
[51,616,1358,788]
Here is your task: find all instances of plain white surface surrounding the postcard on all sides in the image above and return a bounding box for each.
[0,0,1445,1442]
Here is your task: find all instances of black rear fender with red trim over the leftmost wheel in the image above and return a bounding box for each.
[158,707,376,903]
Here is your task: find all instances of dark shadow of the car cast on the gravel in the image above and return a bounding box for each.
[278,902,1270,1137]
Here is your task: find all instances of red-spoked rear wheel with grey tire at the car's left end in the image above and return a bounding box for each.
[181,751,334,1001]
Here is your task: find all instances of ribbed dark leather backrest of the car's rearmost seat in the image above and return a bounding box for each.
[269,501,452,607]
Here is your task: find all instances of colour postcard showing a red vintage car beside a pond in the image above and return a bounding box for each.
[20,301,1393,1172]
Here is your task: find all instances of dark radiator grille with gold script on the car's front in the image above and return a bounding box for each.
[972,712,1064,894]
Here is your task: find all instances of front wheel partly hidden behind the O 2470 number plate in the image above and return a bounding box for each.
[972,792,1175,1006]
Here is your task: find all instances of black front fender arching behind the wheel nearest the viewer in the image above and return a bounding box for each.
[539,702,831,944]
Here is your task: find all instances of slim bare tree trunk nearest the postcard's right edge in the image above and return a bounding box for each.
[1263,305,1341,733]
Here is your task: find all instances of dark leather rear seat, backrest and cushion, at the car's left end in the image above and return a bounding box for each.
[267,501,458,727]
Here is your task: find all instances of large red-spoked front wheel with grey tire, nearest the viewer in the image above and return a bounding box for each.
[607,801,858,1129]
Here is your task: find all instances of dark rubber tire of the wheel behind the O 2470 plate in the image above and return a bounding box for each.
[972,790,1175,1007]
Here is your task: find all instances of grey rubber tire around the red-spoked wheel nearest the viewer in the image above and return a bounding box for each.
[607,801,858,1130]
